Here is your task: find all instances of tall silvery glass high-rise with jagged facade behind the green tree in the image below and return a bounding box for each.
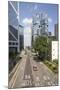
[32,13,48,41]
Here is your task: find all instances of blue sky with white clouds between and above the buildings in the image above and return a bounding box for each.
[19,2,58,46]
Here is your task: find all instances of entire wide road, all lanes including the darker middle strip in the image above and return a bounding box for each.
[9,51,58,88]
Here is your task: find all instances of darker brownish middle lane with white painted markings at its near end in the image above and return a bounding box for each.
[23,54,34,87]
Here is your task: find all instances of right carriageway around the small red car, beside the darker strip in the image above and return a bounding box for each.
[31,54,58,86]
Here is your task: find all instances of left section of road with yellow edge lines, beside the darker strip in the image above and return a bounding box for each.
[9,55,27,88]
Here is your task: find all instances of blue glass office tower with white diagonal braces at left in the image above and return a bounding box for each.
[8,1,19,53]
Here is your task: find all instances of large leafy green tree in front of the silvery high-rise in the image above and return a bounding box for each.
[33,36,48,60]
